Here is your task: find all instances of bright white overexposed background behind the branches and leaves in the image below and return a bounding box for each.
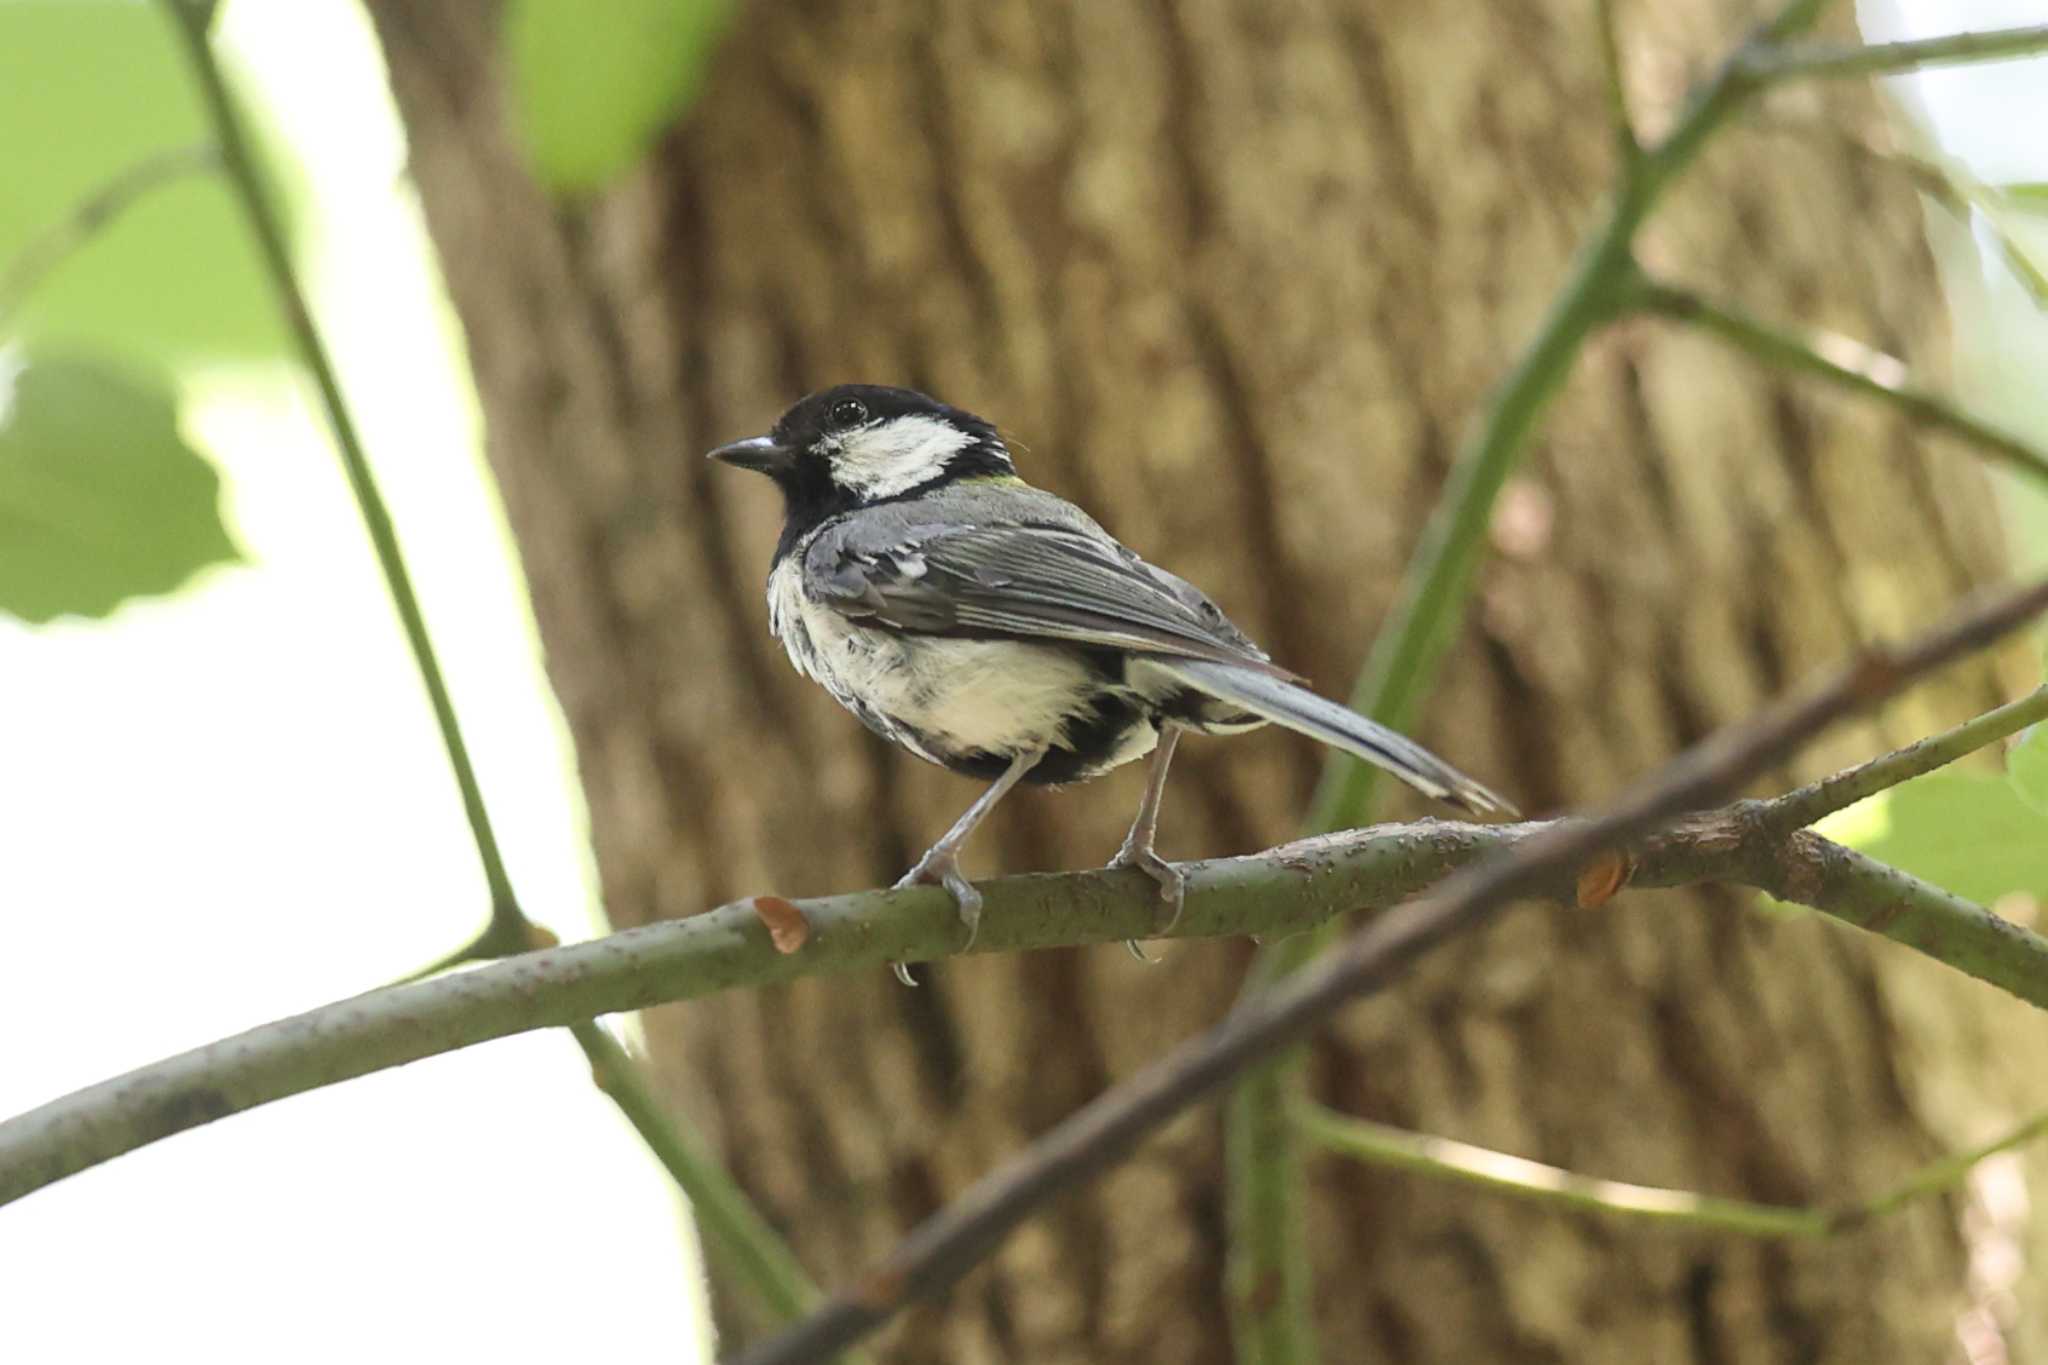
[0,0,2048,1361]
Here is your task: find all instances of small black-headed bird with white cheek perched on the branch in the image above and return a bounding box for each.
[711,385,1513,984]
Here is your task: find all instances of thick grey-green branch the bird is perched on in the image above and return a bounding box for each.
[0,757,2048,1203]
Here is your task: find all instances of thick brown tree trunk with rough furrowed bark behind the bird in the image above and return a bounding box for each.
[369,0,2044,1365]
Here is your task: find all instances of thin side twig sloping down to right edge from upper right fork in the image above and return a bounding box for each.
[1634,280,2048,491]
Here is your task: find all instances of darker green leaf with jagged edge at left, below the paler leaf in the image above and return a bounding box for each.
[0,360,242,622]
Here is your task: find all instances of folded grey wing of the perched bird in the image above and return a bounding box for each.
[805,522,1290,677]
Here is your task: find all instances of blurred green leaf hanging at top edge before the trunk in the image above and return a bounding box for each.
[504,0,731,196]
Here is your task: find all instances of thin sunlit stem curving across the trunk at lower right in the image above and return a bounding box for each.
[1292,1103,2048,1240]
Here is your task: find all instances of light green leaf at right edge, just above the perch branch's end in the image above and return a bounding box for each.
[1821,772,2048,905]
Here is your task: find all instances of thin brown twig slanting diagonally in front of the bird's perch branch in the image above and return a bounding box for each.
[737,581,2048,1365]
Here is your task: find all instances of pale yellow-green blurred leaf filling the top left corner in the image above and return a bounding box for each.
[0,0,299,362]
